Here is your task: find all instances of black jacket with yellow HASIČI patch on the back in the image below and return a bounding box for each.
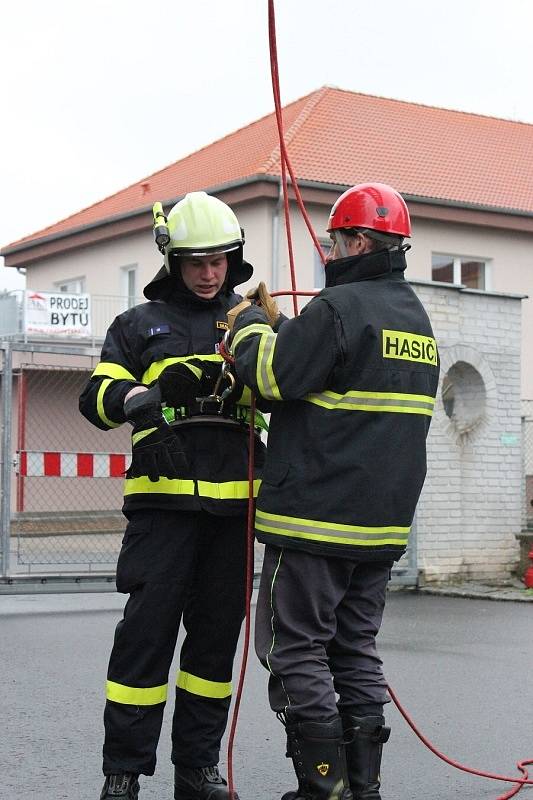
[232,250,439,560]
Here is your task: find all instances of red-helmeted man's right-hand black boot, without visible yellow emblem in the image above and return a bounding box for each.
[342,714,390,800]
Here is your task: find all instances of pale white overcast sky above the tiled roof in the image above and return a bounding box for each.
[0,0,533,289]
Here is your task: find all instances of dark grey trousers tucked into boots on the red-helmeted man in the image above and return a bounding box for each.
[255,545,392,721]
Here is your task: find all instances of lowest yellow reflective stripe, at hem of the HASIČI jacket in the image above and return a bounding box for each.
[255,509,411,547]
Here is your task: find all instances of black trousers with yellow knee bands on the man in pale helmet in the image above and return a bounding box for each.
[103,510,246,775]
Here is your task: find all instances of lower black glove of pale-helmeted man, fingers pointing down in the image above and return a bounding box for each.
[126,422,188,482]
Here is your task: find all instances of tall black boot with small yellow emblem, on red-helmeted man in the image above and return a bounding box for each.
[281,717,353,800]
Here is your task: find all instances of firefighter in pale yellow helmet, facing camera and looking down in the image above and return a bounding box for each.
[80,192,264,800]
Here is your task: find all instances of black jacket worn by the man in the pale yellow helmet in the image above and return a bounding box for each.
[80,262,264,516]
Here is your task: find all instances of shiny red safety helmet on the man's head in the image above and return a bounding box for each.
[327,183,411,236]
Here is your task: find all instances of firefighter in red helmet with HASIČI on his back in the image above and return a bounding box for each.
[228,183,439,800]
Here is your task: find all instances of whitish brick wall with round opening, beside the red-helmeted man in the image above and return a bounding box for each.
[413,283,523,583]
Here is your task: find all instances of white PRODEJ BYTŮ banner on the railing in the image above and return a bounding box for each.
[24,289,91,336]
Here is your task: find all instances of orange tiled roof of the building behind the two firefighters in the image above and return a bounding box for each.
[5,87,533,249]
